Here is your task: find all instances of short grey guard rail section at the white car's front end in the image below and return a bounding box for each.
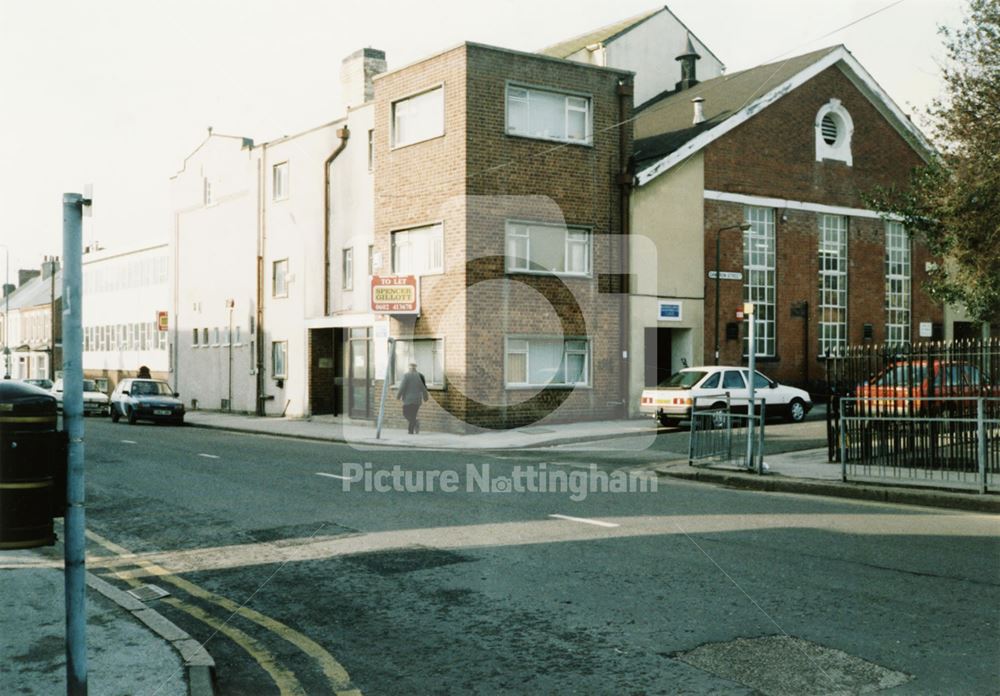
[688,401,766,472]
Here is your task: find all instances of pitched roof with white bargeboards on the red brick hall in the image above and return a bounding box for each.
[634,46,934,186]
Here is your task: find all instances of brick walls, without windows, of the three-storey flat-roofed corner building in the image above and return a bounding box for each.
[375,44,631,429]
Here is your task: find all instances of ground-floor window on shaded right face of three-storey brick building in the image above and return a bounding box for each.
[505,336,590,387]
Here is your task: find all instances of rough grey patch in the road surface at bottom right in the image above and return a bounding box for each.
[672,636,912,696]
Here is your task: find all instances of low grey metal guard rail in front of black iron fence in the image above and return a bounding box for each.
[837,396,1000,493]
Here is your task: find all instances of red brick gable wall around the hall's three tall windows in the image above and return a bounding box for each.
[704,68,943,388]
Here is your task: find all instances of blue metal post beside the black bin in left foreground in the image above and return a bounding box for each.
[62,193,90,696]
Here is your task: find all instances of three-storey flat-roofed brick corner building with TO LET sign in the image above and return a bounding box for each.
[374,43,632,430]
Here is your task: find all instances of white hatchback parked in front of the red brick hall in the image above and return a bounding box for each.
[639,365,812,426]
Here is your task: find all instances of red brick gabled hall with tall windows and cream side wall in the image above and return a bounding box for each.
[631,46,942,402]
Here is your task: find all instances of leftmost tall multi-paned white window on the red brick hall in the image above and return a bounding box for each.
[743,205,777,358]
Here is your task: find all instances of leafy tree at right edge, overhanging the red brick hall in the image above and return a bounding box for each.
[871,0,1000,324]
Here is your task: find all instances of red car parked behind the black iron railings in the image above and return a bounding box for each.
[855,360,1000,414]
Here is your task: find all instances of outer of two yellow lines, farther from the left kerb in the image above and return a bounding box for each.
[87,530,361,696]
